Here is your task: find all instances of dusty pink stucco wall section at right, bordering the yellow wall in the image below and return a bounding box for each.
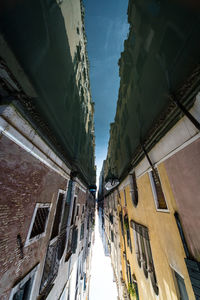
[165,139,200,261]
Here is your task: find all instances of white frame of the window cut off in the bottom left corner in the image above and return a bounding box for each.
[9,264,40,300]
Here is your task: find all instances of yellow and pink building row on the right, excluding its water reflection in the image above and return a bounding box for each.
[101,94,200,299]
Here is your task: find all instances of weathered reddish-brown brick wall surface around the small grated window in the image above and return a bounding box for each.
[0,136,67,300]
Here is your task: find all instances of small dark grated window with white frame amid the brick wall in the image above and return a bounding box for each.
[25,203,50,246]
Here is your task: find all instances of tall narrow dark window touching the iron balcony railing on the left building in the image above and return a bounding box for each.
[51,192,64,240]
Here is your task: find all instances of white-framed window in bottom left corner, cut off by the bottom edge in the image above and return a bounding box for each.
[9,265,39,300]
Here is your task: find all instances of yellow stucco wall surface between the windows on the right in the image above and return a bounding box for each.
[117,164,195,300]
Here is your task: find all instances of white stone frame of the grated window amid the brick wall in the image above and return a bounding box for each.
[24,203,52,247]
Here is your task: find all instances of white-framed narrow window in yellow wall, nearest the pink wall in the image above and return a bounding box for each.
[149,168,168,210]
